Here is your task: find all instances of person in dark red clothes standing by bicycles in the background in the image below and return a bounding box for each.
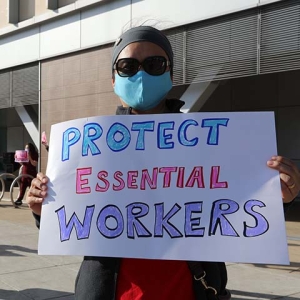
[15,143,39,206]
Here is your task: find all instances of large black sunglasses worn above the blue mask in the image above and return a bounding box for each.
[114,56,171,77]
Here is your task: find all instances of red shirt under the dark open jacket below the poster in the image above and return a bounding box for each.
[116,258,195,300]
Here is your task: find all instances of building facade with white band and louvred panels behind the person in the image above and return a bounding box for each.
[0,0,300,171]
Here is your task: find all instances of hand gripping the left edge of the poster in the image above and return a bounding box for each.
[26,173,48,216]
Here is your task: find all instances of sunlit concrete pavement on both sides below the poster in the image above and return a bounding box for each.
[0,193,300,300]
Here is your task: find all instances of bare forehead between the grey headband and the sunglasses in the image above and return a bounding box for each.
[118,41,168,60]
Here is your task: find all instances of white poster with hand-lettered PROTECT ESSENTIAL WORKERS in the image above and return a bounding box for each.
[39,112,288,264]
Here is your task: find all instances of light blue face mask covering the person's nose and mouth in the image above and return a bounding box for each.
[114,71,172,110]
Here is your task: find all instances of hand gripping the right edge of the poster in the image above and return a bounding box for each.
[267,156,300,203]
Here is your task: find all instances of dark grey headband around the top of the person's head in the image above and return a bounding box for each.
[112,26,173,69]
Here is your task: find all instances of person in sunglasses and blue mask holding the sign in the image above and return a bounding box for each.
[26,26,300,300]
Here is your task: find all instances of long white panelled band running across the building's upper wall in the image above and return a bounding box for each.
[0,0,280,70]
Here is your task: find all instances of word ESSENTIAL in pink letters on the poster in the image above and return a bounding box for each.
[76,166,228,194]
